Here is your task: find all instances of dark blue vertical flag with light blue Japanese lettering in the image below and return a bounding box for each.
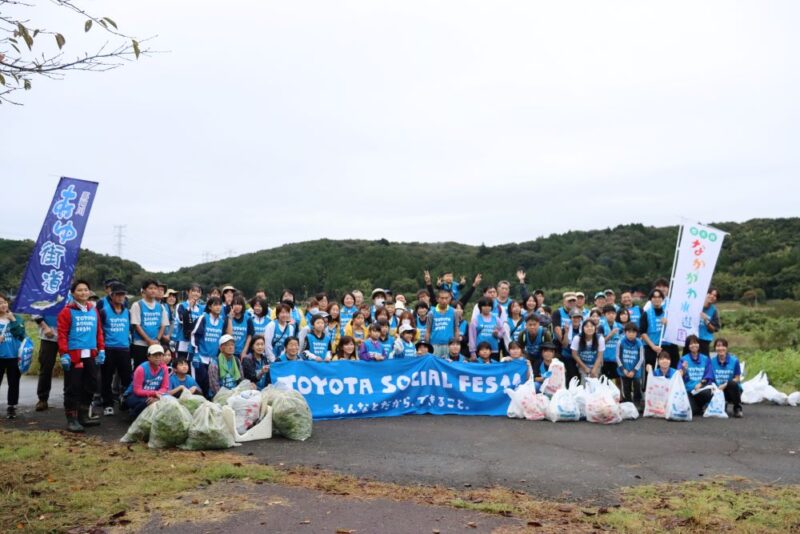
[14,177,97,315]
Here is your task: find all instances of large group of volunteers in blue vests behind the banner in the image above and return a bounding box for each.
[0,271,742,432]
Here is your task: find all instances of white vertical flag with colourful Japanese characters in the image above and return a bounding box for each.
[661,223,727,346]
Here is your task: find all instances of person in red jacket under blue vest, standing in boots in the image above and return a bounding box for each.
[58,280,106,432]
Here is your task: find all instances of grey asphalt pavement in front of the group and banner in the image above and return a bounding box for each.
[6,376,800,501]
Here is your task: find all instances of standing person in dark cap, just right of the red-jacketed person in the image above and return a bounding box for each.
[99,283,131,415]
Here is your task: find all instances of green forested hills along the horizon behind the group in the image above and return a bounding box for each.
[0,218,800,299]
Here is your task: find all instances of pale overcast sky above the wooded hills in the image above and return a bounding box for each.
[0,0,800,270]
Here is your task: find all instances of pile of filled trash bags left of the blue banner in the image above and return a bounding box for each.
[120,380,312,450]
